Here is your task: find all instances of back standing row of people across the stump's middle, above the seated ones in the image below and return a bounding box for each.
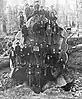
[10,42,64,67]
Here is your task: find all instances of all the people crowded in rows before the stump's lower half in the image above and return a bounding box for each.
[10,37,65,88]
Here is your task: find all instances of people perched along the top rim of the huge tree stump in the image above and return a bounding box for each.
[20,0,57,31]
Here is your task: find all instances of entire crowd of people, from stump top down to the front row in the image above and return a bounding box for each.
[10,1,69,93]
